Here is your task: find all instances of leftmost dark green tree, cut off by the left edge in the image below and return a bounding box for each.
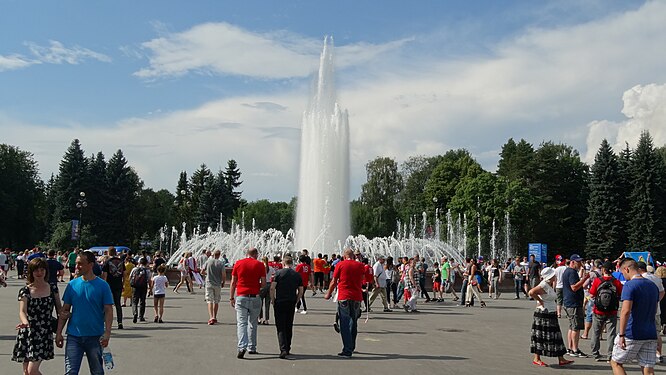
[0,144,44,248]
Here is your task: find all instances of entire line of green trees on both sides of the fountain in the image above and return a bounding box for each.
[0,132,666,258]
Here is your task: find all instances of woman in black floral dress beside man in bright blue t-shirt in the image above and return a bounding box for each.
[12,258,61,375]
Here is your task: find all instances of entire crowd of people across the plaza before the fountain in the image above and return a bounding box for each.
[0,247,666,374]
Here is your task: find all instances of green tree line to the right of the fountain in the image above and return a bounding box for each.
[351,132,666,258]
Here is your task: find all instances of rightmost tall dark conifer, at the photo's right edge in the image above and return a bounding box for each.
[629,131,666,258]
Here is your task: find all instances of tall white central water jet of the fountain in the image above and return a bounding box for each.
[296,37,350,253]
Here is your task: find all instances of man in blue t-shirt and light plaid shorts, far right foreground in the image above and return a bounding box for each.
[611,258,659,374]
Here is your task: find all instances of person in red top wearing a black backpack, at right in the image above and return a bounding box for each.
[590,262,622,361]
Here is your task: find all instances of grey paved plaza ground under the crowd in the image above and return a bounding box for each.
[0,276,666,375]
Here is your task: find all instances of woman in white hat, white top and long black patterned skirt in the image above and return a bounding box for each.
[528,267,573,367]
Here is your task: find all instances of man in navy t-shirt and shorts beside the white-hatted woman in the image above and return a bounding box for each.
[562,254,590,358]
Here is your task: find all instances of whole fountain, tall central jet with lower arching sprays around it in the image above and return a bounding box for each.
[168,37,467,266]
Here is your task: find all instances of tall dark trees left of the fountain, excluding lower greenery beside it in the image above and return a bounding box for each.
[0,139,242,254]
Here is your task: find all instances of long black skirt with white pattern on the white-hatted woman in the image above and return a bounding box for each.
[530,310,567,357]
